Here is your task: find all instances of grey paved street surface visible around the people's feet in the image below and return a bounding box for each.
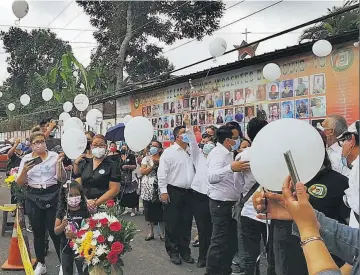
[0,173,265,275]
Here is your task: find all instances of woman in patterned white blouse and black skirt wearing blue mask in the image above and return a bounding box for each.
[140,141,164,241]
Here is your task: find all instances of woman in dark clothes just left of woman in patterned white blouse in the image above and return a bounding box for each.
[119,143,139,217]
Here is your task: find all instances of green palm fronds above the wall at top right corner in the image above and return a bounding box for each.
[300,0,359,42]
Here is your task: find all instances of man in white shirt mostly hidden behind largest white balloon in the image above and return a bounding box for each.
[234,118,275,274]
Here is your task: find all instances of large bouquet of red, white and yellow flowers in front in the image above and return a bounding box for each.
[70,201,136,275]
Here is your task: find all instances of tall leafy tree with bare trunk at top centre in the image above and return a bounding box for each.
[77,1,225,89]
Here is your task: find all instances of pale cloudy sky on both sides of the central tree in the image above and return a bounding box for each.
[0,0,342,83]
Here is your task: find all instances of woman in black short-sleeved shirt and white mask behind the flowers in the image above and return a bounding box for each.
[76,135,120,215]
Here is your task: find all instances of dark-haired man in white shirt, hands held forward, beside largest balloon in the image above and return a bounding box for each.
[206,125,249,275]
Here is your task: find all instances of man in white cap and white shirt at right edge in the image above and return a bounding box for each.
[338,120,360,228]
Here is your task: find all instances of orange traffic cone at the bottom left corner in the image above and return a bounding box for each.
[1,222,35,270]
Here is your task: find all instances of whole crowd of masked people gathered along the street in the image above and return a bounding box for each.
[3,115,359,275]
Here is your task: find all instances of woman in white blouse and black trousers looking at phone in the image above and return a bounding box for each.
[17,132,62,275]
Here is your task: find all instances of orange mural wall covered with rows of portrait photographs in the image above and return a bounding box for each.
[131,45,359,141]
